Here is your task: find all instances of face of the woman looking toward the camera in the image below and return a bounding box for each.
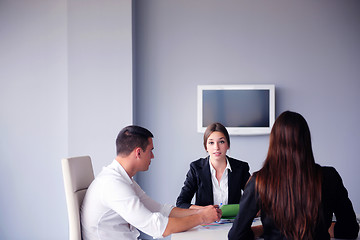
[206,132,229,160]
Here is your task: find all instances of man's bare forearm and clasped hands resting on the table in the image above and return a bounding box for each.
[163,205,222,237]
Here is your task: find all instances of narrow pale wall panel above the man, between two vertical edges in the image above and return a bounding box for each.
[68,0,133,172]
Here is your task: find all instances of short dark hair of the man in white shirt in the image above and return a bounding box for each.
[116,125,154,156]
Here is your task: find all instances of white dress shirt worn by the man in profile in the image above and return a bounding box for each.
[81,160,173,240]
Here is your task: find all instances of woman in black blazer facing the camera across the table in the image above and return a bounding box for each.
[176,123,250,208]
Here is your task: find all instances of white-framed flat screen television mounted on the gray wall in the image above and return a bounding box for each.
[197,85,275,135]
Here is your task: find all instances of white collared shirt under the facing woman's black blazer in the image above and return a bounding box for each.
[209,158,232,206]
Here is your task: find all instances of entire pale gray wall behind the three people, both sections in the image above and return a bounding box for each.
[0,0,360,240]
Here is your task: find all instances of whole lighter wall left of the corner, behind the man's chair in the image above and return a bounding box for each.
[0,0,133,240]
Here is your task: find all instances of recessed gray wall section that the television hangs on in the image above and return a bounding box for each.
[135,0,360,218]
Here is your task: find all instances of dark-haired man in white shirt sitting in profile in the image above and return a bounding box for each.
[81,126,221,240]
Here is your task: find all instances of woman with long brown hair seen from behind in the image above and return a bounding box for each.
[228,111,359,240]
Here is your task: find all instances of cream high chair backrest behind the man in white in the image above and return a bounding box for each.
[61,156,94,240]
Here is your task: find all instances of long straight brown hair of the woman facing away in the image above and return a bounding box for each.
[256,111,321,239]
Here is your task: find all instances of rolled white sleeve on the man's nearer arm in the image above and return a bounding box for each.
[102,176,171,238]
